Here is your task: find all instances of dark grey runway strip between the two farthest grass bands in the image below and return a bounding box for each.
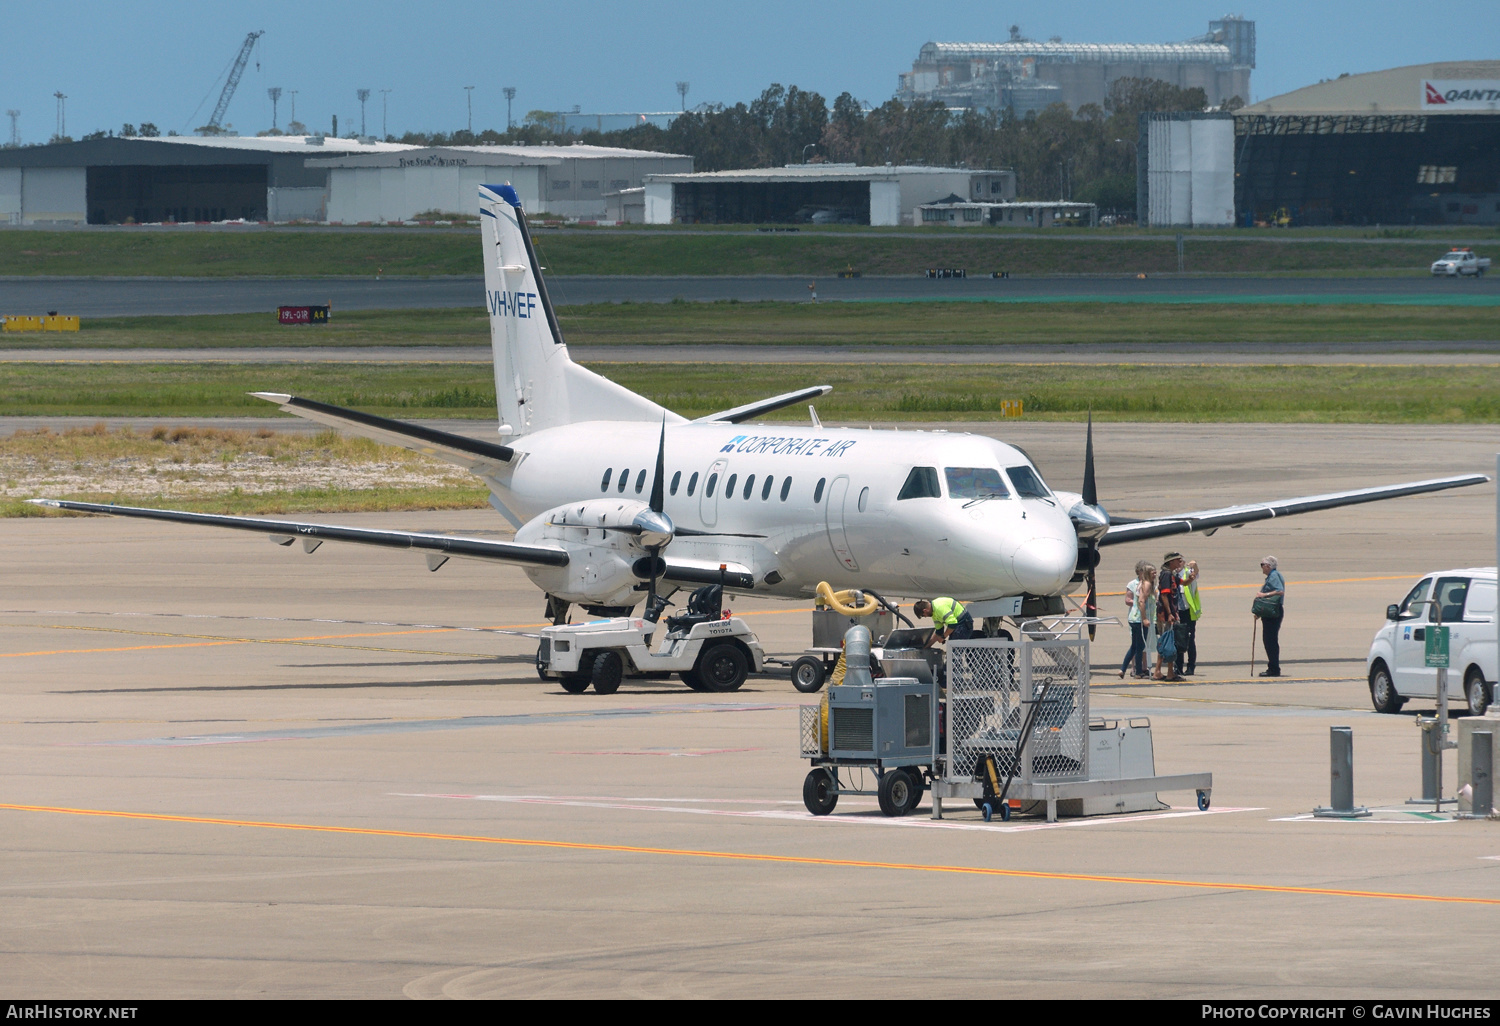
[0,269,1500,317]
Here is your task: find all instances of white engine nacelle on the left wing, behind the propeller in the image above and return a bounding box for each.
[516,498,674,606]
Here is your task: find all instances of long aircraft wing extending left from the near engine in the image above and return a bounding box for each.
[29,500,569,570]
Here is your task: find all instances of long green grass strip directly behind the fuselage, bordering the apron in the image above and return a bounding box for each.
[0,363,1500,423]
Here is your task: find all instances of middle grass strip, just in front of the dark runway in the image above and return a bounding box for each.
[11,297,1500,352]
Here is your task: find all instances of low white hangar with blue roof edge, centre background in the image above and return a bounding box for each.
[645,164,1016,225]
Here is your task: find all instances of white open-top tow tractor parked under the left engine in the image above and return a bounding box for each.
[537,585,765,695]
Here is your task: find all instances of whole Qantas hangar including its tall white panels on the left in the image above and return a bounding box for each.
[1137,60,1500,227]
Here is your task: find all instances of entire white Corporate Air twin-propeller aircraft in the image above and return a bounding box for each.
[35,185,1488,621]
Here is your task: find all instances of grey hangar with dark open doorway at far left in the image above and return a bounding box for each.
[0,135,410,225]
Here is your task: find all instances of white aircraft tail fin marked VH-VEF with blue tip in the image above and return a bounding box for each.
[479,185,683,437]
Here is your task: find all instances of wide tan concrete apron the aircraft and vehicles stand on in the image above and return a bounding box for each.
[0,423,1500,1001]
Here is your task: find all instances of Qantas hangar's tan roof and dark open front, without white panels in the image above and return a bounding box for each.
[1235,60,1500,225]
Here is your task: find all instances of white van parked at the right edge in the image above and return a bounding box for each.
[1365,567,1500,716]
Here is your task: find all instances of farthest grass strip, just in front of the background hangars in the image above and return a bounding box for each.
[0,227,1470,278]
